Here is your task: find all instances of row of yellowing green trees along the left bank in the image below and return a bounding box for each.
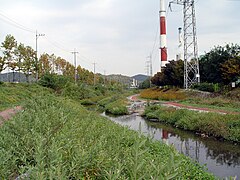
[0,35,104,84]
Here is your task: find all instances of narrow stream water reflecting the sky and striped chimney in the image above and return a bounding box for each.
[103,114,240,179]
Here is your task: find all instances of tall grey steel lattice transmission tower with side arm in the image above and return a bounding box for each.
[169,0,200,89]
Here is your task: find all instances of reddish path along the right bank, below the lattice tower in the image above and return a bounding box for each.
[128,94,239,114]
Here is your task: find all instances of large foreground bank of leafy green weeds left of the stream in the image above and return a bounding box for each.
[0,86,214,179]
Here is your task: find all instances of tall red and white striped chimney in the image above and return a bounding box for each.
[159,0,167,67]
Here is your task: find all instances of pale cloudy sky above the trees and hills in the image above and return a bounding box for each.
[0,0,240,76]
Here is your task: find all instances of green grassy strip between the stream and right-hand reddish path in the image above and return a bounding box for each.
[144,105,240,143]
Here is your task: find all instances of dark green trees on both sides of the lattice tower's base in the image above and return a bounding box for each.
[151,44,240,87]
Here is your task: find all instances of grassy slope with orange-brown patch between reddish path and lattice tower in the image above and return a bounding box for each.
[140,88,240,112]
